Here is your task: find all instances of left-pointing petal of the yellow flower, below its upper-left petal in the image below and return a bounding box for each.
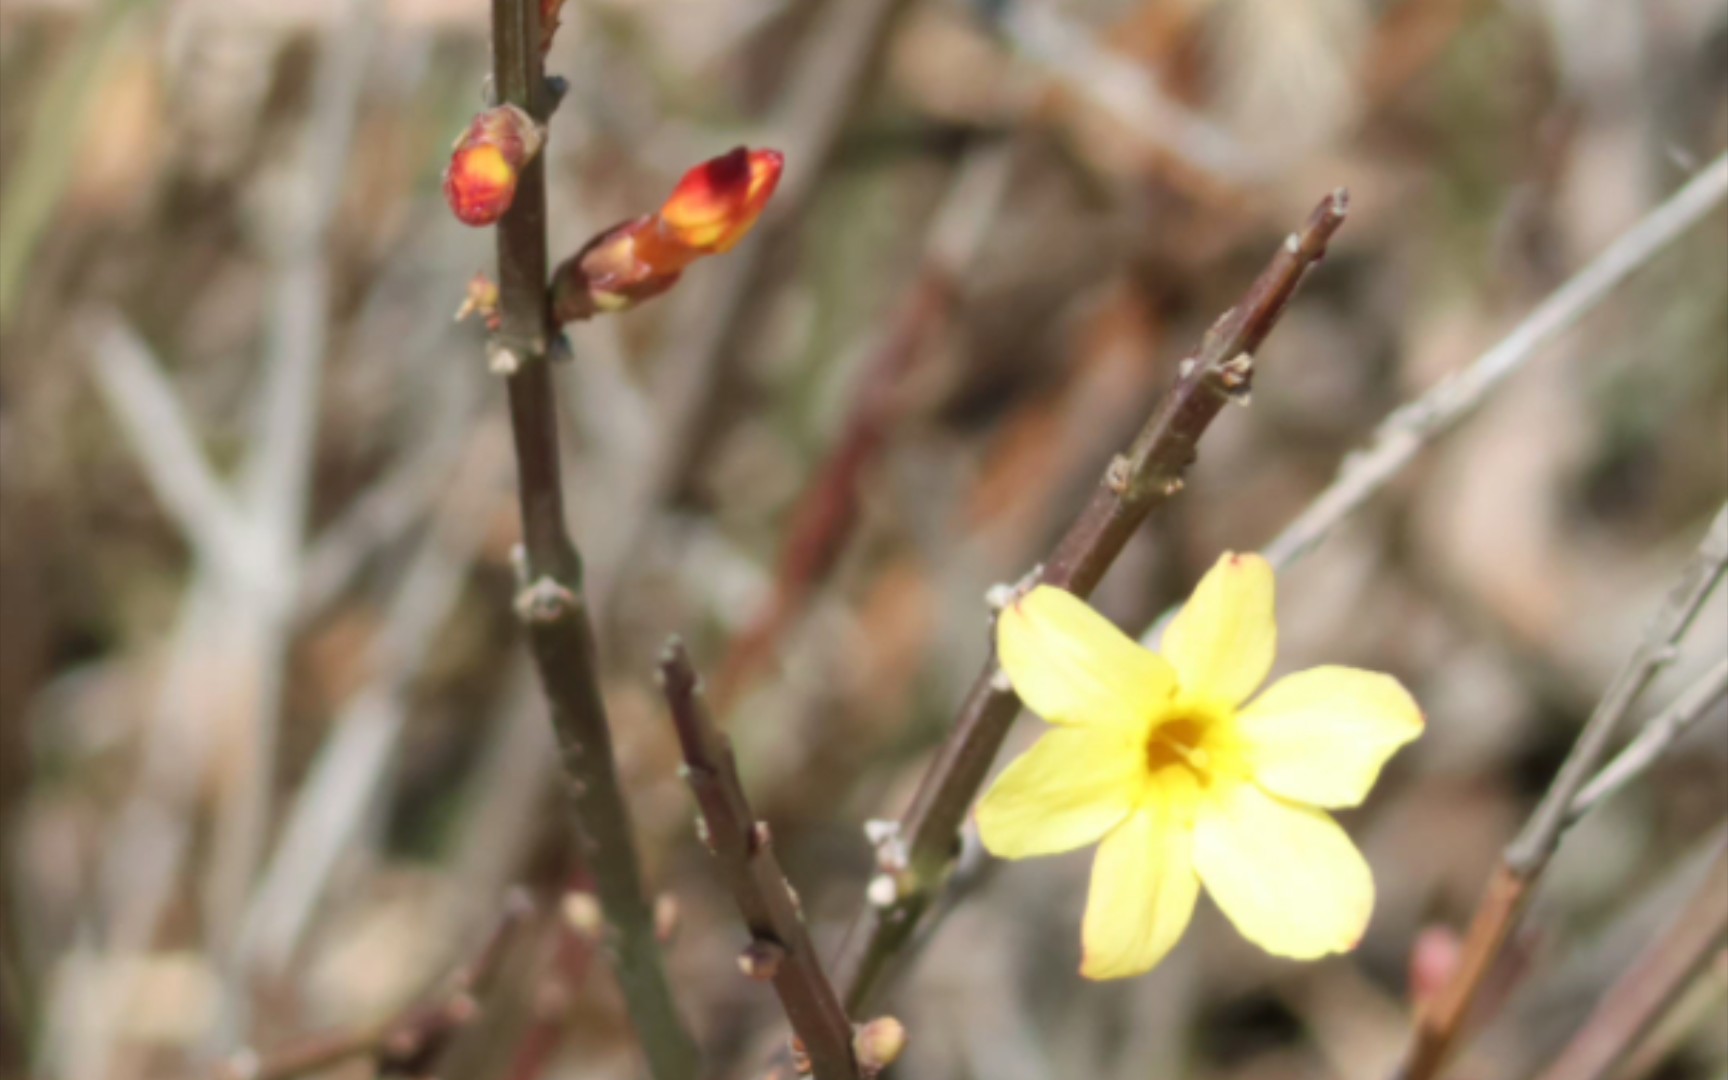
[976,727,1146,859]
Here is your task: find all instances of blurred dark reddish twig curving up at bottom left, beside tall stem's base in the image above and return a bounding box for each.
[226,890,534,1080]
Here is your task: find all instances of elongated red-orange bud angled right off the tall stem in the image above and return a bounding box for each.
[551,147,785,323]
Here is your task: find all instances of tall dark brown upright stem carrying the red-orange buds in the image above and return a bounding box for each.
[492,0,698,1080]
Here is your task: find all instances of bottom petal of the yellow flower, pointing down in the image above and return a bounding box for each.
[1080,805,1199,978]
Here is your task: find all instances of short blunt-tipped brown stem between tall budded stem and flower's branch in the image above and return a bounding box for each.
[660,639,859,1080]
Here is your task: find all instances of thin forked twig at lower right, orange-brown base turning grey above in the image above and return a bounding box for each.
[1400,506,1728,1080]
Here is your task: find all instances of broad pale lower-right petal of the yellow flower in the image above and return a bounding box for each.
[1194,783,1374,959]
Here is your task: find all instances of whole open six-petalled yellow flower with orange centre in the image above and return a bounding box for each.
[978,553,1422,978]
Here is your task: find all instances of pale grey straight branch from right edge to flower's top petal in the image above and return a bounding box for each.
[1261,156,1728,570]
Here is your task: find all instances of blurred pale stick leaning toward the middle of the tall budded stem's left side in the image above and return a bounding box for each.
[235,420,508,978]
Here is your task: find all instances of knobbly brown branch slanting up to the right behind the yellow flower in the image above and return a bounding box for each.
[825,190,1346,1013]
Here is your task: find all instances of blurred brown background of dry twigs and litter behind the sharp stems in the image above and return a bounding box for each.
[0,0,1728,1080]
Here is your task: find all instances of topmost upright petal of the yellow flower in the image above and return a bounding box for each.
[1159,551,1279,708]
